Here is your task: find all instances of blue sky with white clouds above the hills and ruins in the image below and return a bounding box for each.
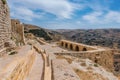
[7,0,120,29]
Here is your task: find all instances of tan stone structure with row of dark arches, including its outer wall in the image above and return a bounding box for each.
[55,40,114,72]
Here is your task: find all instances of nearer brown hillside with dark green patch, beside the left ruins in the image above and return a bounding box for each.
[24,24,63,41]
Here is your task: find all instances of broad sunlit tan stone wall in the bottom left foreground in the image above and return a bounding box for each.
[0,46,36,80]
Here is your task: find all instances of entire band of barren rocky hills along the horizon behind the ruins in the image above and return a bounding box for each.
[24,24,120,48]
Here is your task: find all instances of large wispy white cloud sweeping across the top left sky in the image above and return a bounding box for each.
[8,0,78,19]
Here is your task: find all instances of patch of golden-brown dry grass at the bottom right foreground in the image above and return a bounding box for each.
[75,69,108,80]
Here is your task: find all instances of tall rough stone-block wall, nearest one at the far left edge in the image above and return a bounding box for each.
[0,0,11,51]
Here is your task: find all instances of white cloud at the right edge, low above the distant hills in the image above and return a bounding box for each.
[82,11,120,24]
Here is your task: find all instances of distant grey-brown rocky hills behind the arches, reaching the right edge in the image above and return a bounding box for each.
[56,29,120,48]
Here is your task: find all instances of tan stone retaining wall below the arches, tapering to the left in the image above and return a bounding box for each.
[55,50,114,71]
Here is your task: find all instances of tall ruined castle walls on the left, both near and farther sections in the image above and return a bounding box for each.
[0,0,25,52]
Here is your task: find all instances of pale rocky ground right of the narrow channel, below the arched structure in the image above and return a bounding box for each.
[32,40,119,80]
